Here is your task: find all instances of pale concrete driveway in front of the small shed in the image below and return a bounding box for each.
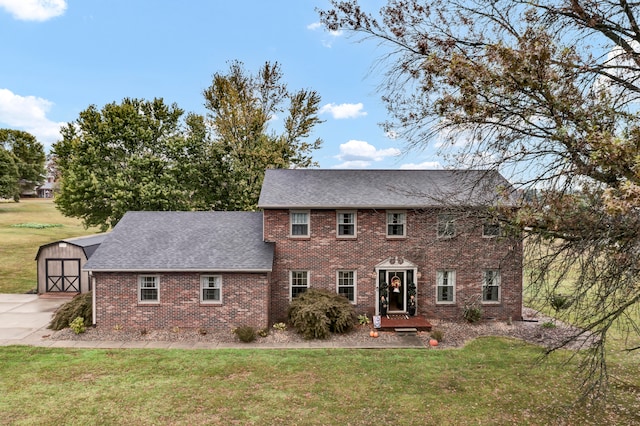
[0,294,71,344]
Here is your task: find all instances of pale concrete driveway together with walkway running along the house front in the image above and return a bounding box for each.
[0,294,425,349]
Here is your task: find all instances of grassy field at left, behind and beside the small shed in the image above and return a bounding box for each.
[0,199,98,293]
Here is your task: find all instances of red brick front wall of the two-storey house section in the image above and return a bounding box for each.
[264,209,522,322]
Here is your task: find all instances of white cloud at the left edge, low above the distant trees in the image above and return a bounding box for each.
[0,88,66,146]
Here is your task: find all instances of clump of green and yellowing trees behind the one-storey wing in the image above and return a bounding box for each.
[53,61,321,230]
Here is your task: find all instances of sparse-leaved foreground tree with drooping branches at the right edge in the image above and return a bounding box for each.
[319,0,640,395]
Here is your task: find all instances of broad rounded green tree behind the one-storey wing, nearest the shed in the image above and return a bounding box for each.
[53,99,217,231]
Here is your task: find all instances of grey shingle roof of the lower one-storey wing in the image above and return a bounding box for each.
[84,212,273,272]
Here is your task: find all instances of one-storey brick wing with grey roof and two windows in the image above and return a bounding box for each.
[84,212,273,329]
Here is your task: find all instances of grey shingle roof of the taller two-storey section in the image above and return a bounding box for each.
[258,169,513,209]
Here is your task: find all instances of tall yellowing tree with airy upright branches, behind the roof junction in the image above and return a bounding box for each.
[204,61,322,210]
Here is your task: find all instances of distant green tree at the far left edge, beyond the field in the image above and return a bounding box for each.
[0,129,45,200]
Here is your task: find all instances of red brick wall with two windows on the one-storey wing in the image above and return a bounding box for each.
[94,272,269,330]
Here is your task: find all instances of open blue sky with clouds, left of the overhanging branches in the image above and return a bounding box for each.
[0,0,442,169]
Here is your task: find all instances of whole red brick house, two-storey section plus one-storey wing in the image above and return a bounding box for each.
[84,169,522,328]
